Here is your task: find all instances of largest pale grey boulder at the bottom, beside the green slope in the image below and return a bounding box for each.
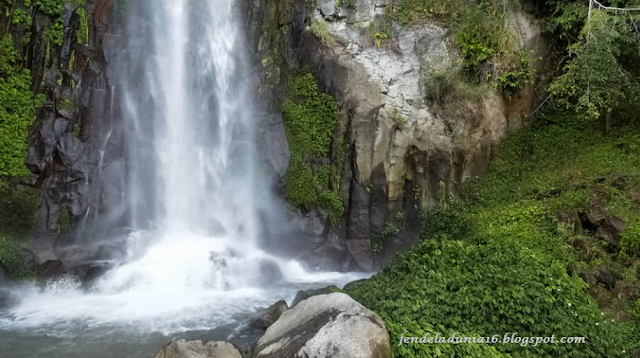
[254,293,391,358]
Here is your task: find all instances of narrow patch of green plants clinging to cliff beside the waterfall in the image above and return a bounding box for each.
[282,74,344,225]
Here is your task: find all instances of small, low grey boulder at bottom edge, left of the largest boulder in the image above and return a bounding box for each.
[154,339,242,358]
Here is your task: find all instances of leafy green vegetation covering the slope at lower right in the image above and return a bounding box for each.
[348,119,640,357]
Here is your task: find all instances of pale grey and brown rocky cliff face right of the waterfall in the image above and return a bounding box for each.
[252,0,544,270]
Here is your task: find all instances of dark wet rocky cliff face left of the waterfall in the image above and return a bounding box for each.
[8,0,124,261]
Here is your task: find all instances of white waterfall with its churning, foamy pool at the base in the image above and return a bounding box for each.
[0,0,364,358]
